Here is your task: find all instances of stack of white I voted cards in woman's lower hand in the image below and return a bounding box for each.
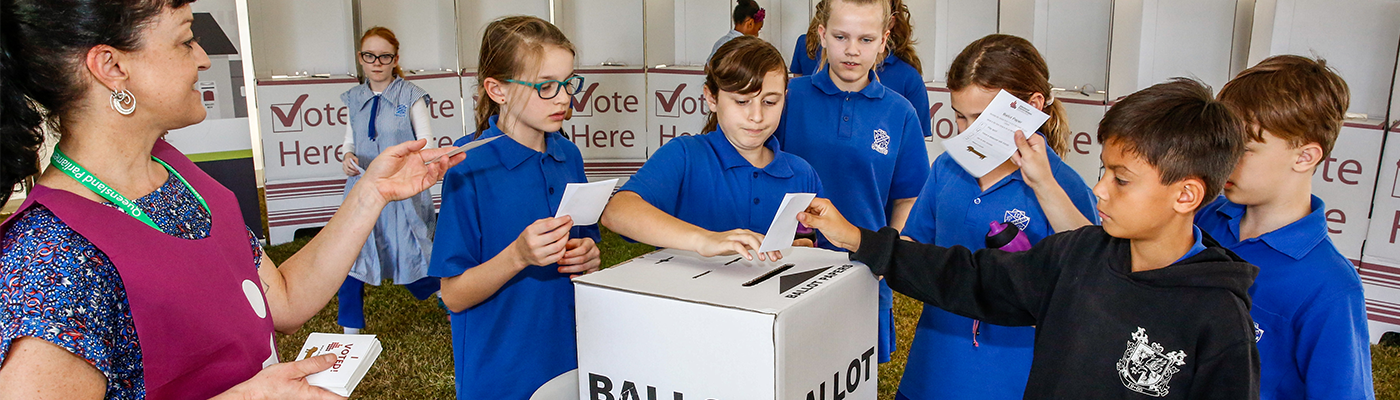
[297,333,384,397]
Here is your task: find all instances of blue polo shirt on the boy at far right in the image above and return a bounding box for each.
[1196,196,1376,400]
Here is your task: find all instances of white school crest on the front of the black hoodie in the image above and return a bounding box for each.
[1117,326,1186,397]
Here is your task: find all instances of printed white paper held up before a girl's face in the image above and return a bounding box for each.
[944,91,1050,178]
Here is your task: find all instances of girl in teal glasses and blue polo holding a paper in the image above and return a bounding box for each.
[428,17,599,399]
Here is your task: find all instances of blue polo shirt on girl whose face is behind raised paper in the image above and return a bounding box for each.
[899,151,1099,400]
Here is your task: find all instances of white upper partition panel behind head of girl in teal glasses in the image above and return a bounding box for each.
[456,0,551,70]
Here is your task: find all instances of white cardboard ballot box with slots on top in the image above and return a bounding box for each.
[574,248,879,400]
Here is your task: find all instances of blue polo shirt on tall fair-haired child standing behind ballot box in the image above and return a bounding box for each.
[773,64,928,362]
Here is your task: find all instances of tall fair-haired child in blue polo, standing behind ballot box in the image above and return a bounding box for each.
[774,0,928,362]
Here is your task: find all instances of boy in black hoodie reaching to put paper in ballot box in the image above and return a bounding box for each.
[798,78,1259,400]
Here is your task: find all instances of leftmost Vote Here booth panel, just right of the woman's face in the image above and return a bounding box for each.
[248,0,358,245]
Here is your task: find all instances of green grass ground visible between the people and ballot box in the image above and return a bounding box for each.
[267,231,1400,400]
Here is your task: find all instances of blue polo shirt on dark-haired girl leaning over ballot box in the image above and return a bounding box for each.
[622,130,822,234]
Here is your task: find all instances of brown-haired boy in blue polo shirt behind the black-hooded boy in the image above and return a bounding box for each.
[1196,56,1375,400]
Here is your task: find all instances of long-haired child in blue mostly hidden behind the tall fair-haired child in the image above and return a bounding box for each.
[790,0,934,137]
